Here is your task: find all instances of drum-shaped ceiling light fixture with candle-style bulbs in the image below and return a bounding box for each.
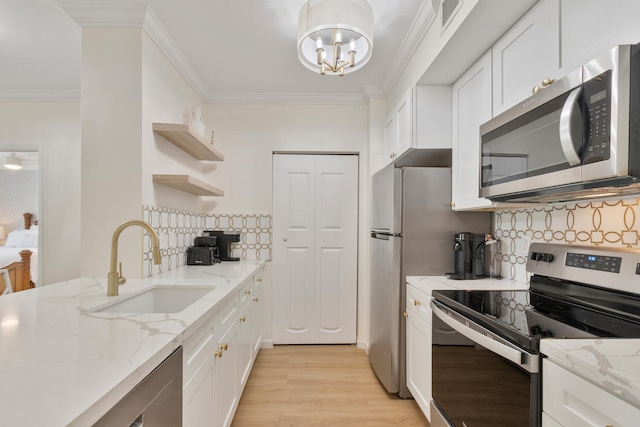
[298,0,373,76]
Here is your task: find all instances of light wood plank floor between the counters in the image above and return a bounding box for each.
[232,345,429,427]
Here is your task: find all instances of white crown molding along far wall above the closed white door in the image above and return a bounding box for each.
[204,92,367,105]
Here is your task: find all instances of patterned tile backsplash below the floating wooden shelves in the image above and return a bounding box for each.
[142,205,272,277]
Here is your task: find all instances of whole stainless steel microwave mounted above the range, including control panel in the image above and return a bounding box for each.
[480,44,640,202]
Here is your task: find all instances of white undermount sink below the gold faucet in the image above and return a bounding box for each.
[92,285,216,313]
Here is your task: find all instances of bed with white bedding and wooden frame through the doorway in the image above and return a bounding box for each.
[0,213,38,295]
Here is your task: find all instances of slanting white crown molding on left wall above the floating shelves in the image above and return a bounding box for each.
[142,8,209,102]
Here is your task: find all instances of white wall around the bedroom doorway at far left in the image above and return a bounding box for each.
[0,102,81,284]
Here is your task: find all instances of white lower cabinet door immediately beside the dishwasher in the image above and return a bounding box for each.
[182,352,215,427]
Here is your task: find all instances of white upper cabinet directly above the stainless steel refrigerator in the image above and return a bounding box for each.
[384,85,451,164]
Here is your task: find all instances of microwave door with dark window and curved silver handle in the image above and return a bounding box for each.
[480,69,584,198]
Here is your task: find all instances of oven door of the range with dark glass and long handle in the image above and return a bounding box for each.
[431,301,541,427]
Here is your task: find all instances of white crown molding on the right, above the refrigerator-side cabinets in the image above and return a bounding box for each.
[382,0,437,93]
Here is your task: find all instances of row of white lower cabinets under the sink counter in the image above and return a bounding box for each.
[182,268,264,427]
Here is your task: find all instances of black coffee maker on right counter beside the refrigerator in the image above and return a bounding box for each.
[445,232,490,280]
